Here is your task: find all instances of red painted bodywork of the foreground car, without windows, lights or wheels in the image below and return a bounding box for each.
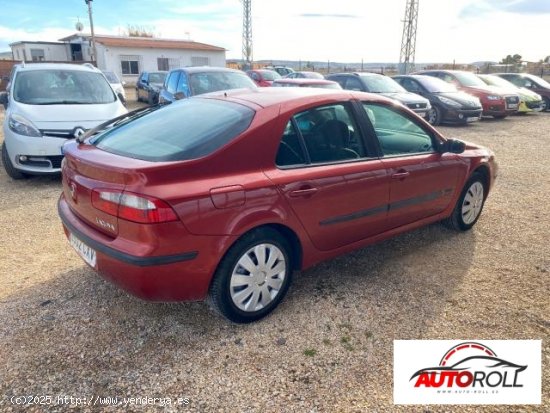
[59,88,496,301]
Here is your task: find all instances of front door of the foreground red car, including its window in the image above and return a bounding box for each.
[362,102,462,228]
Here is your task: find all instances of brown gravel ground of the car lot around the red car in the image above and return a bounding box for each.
[0,96,550,412]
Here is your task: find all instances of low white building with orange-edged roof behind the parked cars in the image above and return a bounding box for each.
[10,33,225,83]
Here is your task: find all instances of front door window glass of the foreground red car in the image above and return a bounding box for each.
[363,103,435,156]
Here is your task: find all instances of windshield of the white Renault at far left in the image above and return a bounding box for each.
[13,69,116,105]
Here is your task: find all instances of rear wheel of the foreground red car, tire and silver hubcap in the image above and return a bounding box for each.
[208,228,293,323]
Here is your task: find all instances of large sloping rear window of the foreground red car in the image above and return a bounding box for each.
[93,98,255,162]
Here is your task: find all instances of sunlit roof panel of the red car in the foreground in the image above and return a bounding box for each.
[198,87,394,108]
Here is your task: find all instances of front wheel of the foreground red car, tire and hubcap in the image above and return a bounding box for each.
[443,173,487,231]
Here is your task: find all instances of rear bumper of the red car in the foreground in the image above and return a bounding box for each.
[58,195,233,302]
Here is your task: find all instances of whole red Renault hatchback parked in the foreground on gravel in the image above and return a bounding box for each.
[58,88,496,323]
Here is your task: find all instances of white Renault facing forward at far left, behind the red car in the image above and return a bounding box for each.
[0,63,126,179]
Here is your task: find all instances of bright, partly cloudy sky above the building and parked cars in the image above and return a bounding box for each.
[0,0,550,63]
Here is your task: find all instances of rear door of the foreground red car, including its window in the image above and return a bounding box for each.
[266,102,389,251]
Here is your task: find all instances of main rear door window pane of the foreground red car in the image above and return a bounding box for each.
[294,104,366,163]
